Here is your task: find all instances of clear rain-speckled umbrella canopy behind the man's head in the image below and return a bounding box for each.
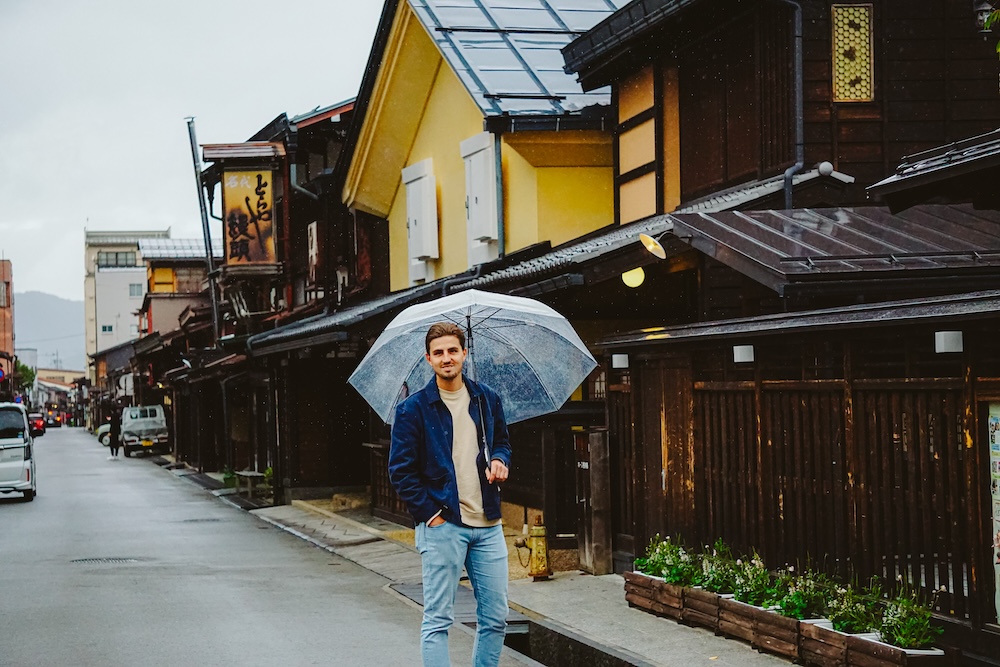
[348,290,597,424]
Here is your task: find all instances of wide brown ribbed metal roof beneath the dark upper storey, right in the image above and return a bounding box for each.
[665,205,1000,293]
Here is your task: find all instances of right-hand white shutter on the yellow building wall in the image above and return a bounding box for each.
[459,132,498,244]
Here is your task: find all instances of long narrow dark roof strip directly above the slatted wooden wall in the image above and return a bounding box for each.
[597,290,1000,348]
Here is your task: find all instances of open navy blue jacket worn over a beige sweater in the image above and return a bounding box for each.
[389,378,510,525]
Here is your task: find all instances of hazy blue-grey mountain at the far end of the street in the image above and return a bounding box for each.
[14,292,87,371]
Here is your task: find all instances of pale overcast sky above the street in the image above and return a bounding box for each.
[0,0,382,300]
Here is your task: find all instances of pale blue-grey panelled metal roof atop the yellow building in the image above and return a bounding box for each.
[409,0,626,117]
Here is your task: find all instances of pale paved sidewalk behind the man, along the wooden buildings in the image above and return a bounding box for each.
[240,501,791,667]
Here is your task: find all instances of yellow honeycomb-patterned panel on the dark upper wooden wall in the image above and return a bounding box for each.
[831,5,875,102]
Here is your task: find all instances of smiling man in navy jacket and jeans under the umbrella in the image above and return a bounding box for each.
[389,322,510,667]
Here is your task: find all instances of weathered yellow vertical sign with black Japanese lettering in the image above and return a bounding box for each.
[222,170,277,265]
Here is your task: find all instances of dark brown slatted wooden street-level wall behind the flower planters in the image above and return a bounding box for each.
[610,319,1000,664]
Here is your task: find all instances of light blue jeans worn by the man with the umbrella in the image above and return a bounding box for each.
[414,521,507,667]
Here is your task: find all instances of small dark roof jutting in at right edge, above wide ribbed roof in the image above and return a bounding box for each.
[868,129,1000,210]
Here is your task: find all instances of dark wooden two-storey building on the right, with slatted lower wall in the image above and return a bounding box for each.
[563,0,1000,664]
